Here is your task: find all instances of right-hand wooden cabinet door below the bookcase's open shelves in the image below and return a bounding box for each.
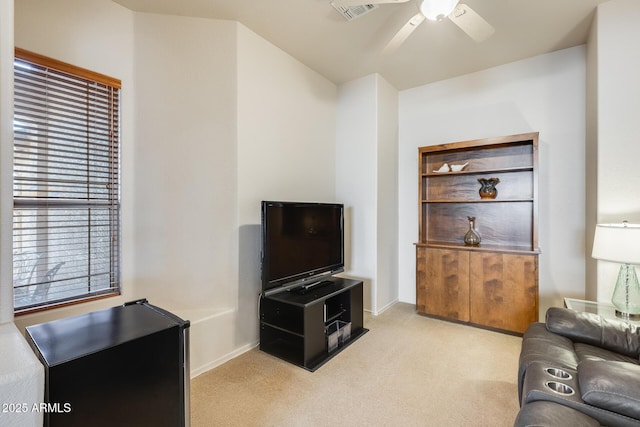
[470,252,538,333]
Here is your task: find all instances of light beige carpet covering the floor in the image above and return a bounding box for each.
[191,303,522,427]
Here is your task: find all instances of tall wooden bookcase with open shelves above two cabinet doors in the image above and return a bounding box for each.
[416,133,539,334]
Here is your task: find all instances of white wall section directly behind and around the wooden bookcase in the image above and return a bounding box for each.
[398,46,585,314]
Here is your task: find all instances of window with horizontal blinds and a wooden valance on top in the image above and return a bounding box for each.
[13,48,121,314]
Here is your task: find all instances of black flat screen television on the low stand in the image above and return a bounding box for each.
[262,201,344,294]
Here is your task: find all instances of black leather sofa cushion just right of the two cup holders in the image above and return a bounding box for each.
[578,359,640,419]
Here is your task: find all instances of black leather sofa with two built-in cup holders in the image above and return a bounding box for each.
[515,307,640,427]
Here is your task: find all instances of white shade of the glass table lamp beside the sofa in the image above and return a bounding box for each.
[591,221,640,264]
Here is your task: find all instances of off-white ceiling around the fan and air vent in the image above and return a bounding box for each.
[114,0,607,90]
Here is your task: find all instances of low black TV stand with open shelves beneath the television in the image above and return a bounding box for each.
[260,277,368,371]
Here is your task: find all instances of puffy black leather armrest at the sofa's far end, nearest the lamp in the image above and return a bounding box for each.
[545,307,640,359]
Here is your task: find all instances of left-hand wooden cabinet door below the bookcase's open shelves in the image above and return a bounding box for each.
[416,247,469,322]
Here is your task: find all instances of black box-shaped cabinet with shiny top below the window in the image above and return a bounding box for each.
[26,300,189,427]
